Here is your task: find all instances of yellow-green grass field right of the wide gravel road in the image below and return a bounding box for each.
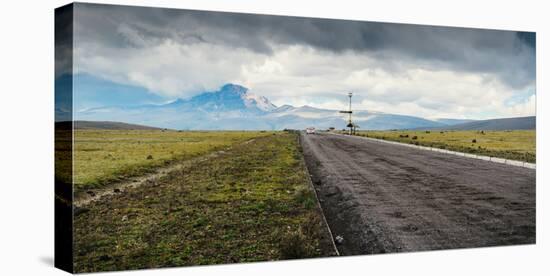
[358,130,536,163]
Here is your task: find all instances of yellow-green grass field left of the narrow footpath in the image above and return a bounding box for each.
[74,130,270,192]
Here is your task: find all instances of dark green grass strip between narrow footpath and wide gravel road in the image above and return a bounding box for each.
[74,132,331,272]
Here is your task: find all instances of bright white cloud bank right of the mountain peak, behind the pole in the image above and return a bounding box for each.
[237,46,534,118]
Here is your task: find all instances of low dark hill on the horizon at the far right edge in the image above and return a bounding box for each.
[438,116,536,130]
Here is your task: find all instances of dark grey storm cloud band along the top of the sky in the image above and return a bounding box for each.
[76,4,536,89]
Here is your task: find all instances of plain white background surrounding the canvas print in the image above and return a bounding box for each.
[0,0,550,275]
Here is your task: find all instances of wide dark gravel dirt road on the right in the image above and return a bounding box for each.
[301,134,535,255]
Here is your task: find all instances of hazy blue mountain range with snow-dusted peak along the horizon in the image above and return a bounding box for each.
[71,84,536,130]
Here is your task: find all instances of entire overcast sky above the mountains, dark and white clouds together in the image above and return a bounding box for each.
[74,4,535,119]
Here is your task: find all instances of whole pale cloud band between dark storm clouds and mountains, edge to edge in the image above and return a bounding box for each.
[75,36,535,119]
